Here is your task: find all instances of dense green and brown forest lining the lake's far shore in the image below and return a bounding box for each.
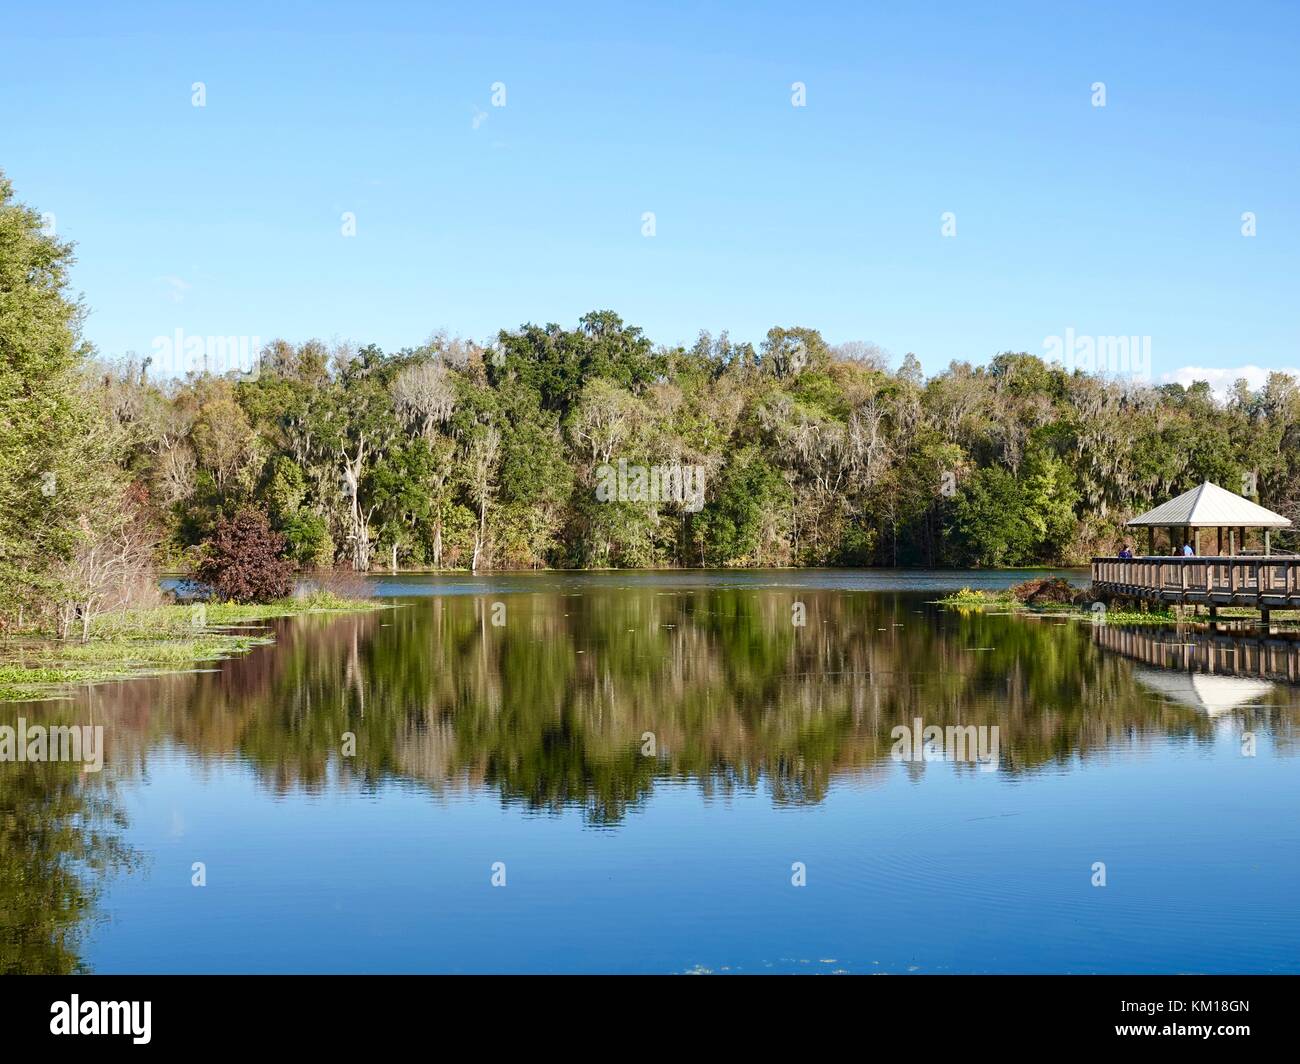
[0,167,1300,627]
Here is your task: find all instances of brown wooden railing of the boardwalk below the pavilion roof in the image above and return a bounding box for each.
[1092,554,1300,609]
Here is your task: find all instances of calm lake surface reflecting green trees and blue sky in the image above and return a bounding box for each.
[0,571,1300,973]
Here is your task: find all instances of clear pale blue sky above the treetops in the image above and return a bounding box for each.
[0,0,1300,380]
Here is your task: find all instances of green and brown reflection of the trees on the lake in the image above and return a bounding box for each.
[0,585,1297,970]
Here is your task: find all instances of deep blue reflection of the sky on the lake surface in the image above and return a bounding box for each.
[91,738,1300,972]
